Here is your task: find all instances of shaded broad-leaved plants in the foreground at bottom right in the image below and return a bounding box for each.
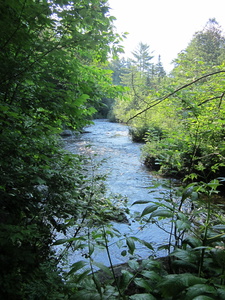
[58,180,225,300]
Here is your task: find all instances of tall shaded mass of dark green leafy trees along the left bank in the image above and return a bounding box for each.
[0,0,125,299]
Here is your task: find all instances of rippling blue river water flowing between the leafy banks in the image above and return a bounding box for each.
[62,120,168,265]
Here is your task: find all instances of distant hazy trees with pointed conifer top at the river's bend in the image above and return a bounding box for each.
[110,43,166,122]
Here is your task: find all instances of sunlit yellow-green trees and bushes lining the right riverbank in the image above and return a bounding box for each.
[114,19,225,181]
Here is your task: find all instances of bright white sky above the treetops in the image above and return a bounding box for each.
[108,0,225,72]
